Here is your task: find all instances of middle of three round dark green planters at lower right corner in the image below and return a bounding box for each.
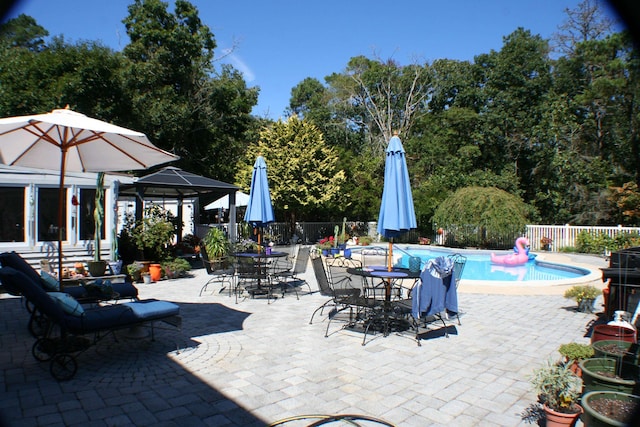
[580,357,638,395]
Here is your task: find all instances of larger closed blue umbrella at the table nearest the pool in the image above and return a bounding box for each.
[378,135,417,271]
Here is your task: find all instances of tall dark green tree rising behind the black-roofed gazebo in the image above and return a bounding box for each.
[123,0,258,179]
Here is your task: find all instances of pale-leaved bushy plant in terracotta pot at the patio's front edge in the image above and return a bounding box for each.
[531,361,582,426]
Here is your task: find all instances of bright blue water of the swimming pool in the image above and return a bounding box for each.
[394,248,590,282]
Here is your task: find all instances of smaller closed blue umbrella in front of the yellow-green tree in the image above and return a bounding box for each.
[244,156,275,248]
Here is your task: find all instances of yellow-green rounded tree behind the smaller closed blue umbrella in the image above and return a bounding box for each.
[236,115,348,224]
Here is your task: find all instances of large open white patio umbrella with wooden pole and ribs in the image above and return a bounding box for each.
[0,107,179,286]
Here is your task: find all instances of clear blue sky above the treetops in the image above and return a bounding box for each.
[3,0,615,119]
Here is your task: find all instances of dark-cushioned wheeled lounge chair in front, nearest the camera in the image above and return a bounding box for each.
[0,266,181,381]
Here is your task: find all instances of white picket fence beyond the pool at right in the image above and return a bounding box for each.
[527,224,640,251]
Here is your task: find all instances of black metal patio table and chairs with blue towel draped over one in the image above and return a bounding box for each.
[310,254,466,345]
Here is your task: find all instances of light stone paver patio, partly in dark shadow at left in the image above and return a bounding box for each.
[0,254,606,427]
